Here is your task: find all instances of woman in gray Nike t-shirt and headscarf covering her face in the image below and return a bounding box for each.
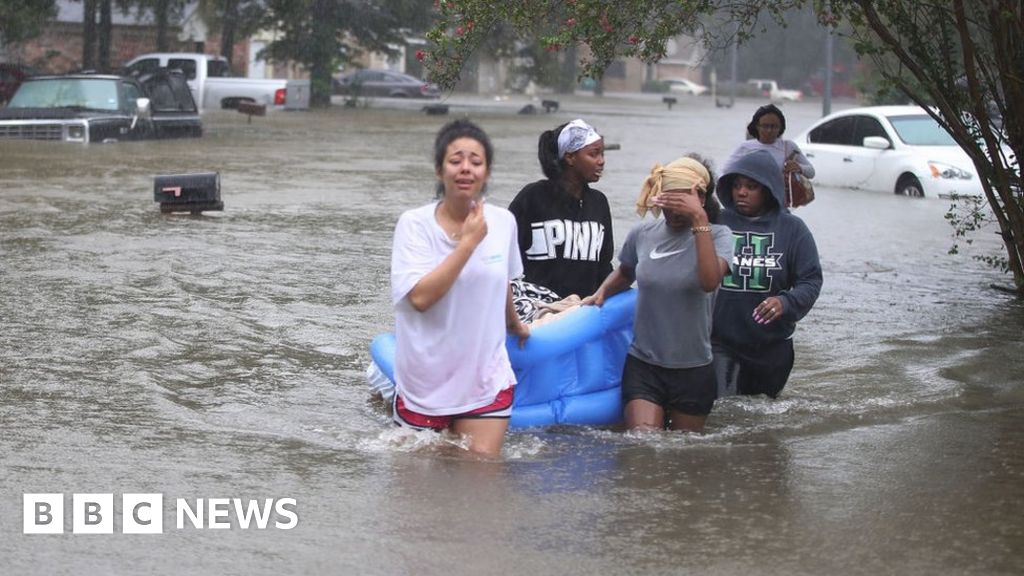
[584,157,733,431]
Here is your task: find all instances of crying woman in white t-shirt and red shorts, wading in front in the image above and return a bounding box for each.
[391,120,529,456]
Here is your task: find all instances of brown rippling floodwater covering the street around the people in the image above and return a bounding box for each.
[6,97,1024,576]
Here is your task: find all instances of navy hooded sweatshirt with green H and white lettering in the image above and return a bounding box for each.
[712,150,822,354]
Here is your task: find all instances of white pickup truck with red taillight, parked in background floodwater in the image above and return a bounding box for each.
[125,52,287,109]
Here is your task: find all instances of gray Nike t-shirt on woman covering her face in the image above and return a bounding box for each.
[618,218,733,368]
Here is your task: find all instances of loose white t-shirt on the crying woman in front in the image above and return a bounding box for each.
[391,202,522,416]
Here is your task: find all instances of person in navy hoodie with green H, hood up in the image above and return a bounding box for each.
[712,150,822,398]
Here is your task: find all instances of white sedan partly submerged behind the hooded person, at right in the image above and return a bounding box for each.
[796,106,983,198]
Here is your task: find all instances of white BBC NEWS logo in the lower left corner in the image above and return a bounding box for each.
[23,493,299,534]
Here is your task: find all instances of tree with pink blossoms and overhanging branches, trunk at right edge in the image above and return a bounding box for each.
[423,0,1024,297]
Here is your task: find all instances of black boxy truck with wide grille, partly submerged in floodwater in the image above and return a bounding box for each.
[0,70,203,143]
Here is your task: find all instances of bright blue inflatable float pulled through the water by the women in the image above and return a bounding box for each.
[367,289,636,428]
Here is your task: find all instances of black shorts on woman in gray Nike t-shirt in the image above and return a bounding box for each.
[623,355,718,416]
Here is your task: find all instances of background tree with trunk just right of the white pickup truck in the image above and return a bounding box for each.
[263,0,430,108]
